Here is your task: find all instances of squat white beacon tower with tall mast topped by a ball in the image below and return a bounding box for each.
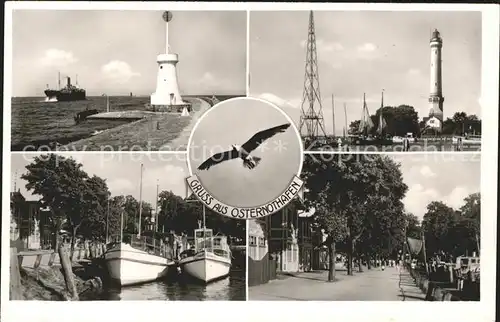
[151,11,189,111]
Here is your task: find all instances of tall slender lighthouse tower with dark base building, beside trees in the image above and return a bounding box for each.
[427,29,444,131]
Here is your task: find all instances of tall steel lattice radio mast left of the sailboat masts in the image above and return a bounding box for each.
[299,11,326,139]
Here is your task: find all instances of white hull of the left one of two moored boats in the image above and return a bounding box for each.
[104,243,169,286]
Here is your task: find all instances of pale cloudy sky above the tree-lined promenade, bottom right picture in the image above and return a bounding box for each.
[393,153,481,219]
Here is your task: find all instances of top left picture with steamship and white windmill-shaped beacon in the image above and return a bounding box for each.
[8,8,247,152]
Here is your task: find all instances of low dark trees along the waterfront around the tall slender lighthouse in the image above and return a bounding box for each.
[348,105,481,136]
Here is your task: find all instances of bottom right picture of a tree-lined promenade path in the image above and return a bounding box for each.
[247,153,481,301]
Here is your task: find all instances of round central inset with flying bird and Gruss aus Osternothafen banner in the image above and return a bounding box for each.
[187,97,303,219]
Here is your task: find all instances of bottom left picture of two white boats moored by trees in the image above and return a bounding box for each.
[10,152,246,301]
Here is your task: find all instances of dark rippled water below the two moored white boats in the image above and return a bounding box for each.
[92,270,246,301]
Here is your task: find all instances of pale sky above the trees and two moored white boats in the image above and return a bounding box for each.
[11,153,188,206]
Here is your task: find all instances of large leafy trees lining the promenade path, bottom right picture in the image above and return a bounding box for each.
[303,154,480,281]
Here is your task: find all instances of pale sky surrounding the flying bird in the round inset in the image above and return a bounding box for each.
[188,99,302,207]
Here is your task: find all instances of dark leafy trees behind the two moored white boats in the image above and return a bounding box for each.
[21,154,245,252]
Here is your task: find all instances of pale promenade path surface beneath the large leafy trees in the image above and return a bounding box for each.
[248,267,425,301]
